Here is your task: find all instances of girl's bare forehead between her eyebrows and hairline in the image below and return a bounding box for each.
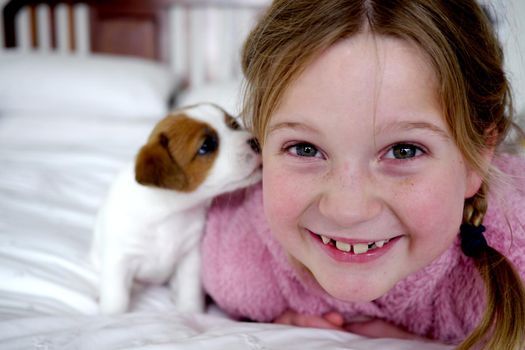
[269,32,441,134]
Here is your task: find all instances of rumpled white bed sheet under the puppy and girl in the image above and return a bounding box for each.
[0,113,449,350]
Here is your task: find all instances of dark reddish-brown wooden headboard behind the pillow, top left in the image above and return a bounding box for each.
[3,0,169,61]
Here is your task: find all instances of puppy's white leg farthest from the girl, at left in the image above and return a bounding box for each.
[99,260,133,315]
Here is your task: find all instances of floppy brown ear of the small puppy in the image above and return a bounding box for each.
[135,134,188,191]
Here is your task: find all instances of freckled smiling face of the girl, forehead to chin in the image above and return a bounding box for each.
[262,33,481,301]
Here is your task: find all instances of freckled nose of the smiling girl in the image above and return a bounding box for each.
[319,166,383,227]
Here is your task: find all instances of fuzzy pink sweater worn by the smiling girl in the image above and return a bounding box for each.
[202,156,525,343]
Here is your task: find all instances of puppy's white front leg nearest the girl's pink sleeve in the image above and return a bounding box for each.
[170,247,204,313]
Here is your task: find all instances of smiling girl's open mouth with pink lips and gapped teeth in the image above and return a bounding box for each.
[307,230,403,263]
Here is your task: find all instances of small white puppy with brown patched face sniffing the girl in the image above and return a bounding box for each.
[91,104,261,314]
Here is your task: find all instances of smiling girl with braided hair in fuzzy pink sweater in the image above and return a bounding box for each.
[203,0,525,349]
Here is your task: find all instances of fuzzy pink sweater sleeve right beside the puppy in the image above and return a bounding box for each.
[202,186,286,322]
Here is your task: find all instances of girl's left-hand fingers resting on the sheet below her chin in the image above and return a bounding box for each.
[273,310,345,331]
